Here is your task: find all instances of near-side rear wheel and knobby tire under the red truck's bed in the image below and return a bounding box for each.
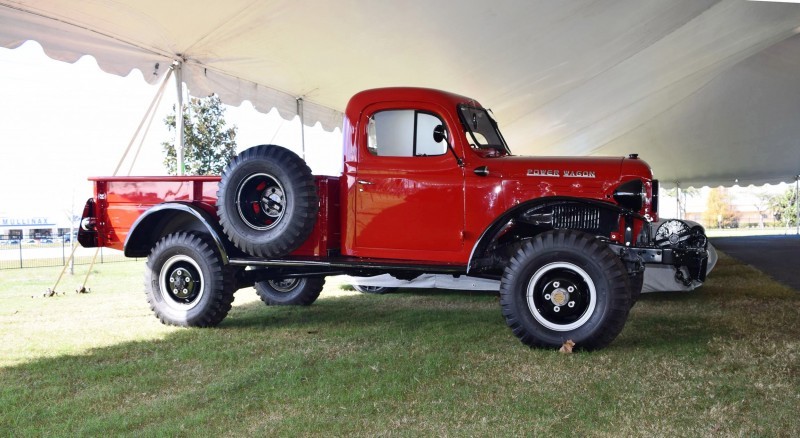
[145,232,235,327]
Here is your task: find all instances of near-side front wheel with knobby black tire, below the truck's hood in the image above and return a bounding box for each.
[500,230,631,350]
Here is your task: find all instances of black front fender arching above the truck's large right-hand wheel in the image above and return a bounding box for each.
[467,196,645,272]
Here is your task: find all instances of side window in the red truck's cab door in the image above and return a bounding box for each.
[367,110,447,157]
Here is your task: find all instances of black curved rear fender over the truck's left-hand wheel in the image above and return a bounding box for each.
[124,202,231,264]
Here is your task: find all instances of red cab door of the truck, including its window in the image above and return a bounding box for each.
[355,106,464,261]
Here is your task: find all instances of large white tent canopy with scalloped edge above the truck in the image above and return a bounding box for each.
[0,0,800,187]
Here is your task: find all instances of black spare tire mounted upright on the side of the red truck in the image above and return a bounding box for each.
[217,145,319,257]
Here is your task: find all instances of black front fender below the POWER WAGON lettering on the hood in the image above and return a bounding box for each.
[467,196,646,272]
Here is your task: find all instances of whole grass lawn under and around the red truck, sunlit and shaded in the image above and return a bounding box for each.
[0,254,800,437]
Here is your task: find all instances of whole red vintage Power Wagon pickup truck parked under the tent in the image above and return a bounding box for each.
[79,88,707,349]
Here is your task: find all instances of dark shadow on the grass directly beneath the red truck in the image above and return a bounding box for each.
[221,289,729,351]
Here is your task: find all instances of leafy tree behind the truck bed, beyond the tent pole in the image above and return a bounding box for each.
[161,94,237,175]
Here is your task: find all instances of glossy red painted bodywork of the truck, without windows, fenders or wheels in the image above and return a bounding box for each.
[86,88,657,264]
